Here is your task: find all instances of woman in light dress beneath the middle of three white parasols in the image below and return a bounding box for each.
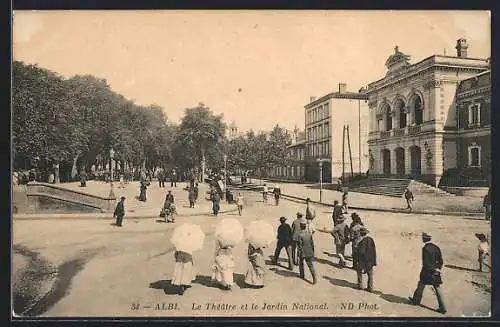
[212,240,235,291]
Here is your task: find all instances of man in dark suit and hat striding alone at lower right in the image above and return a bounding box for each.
[409,233,446,314]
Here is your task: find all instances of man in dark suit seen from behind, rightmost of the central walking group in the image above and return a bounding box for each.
[356,226,377,292]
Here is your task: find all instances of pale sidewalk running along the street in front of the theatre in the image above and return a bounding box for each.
[234,179,484,217]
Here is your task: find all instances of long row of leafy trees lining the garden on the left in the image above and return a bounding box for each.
[12,61,291,180]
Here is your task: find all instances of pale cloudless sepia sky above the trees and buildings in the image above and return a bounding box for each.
[13,10,491,131]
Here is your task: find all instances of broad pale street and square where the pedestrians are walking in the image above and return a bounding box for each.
[13,183,491,316]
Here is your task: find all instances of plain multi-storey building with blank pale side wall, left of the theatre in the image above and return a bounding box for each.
[304,83,369,182]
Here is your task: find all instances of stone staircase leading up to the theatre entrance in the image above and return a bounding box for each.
[349,178,453,197]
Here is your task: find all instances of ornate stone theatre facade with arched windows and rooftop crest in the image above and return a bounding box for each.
[365,39,488,186]
